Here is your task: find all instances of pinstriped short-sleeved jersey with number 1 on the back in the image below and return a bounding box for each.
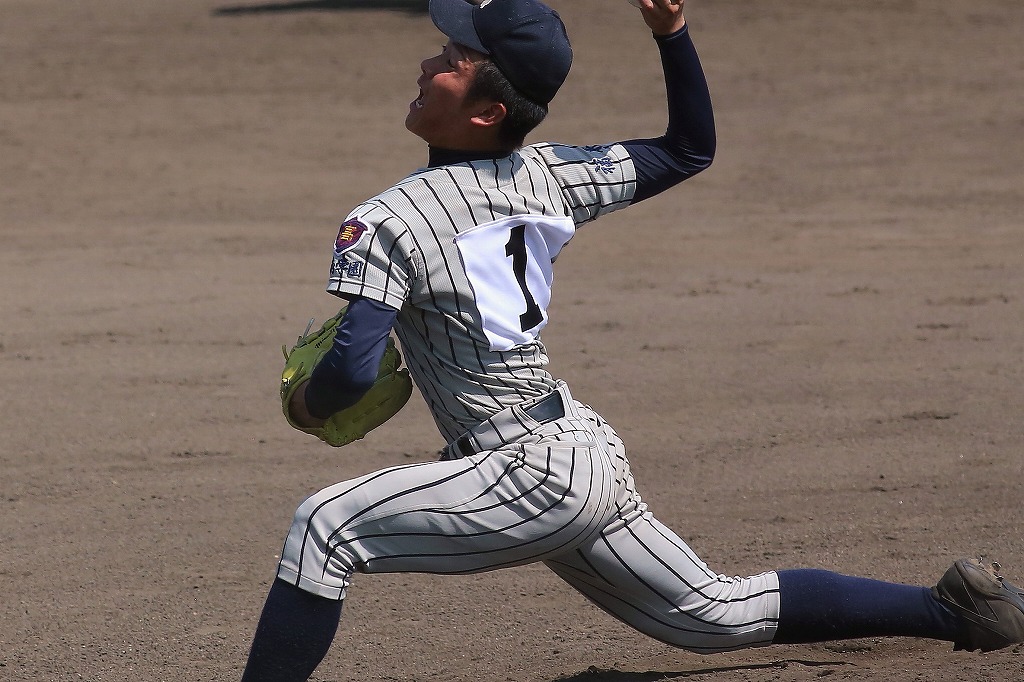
[328,142,636,441]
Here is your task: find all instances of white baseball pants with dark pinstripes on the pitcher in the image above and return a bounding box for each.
[278,384,779,653]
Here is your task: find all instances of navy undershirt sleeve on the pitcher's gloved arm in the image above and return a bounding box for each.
[305,298,398,419]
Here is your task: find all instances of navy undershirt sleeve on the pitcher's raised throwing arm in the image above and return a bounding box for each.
[622,26,716,204]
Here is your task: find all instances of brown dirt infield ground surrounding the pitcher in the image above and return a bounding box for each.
[0,0,1024,682]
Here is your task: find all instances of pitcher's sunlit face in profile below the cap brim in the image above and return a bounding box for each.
[406,41,484,150]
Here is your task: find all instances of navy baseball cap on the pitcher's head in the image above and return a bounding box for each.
[430,0,572,106]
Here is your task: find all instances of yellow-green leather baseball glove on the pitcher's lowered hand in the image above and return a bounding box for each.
[281,308,413,447]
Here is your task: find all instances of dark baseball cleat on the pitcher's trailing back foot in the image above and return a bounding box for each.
[932,559,1024,651]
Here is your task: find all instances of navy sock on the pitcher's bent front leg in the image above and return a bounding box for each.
[242,579,342,682]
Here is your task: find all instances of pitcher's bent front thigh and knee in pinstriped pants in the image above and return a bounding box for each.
[282,442,612,580]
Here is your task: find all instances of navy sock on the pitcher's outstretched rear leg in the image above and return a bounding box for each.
[773,568,957,644]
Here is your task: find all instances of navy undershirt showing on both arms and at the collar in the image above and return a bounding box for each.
[305,27,716,419]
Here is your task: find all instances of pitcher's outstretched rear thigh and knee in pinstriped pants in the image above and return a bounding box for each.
[547,504,778,653]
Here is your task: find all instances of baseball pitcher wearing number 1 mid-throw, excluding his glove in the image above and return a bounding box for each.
[237,0,1024,682]
